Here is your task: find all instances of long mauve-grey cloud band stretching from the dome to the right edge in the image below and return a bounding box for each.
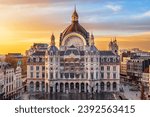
[83,16,150,33]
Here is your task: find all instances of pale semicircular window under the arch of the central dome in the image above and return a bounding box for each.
[65,36,84,46]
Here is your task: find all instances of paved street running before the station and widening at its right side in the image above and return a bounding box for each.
[21,83,149,100]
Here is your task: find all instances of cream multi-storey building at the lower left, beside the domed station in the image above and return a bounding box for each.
[0,62,23,99]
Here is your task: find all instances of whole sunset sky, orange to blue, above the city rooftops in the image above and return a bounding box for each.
[0,0,150,54]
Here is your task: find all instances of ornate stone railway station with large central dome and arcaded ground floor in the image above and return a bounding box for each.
[27,10,120,93]
